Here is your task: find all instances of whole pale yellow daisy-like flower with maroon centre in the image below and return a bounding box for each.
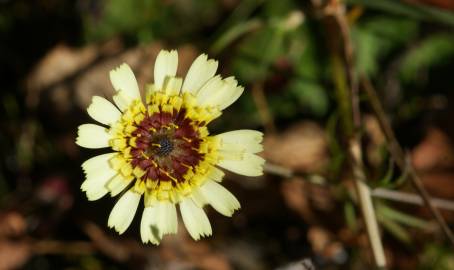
[76,50,264,244]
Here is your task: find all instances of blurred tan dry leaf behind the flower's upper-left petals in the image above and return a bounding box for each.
[26,40,198,113]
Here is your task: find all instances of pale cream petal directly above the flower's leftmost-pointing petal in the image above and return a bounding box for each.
[87,96,121,125]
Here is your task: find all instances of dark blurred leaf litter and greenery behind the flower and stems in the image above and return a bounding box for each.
[0,0,454,270]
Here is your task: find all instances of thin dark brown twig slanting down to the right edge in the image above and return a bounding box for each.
[361,76,454,246]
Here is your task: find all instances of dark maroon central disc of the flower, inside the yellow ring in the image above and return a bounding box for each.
[130,109,203,184]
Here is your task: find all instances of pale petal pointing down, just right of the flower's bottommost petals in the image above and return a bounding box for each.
[180,197,212,240]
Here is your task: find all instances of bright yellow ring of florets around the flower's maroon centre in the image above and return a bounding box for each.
[109,91,221,206]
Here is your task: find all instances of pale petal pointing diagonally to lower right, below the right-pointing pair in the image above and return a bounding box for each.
[200,180,241,217]
